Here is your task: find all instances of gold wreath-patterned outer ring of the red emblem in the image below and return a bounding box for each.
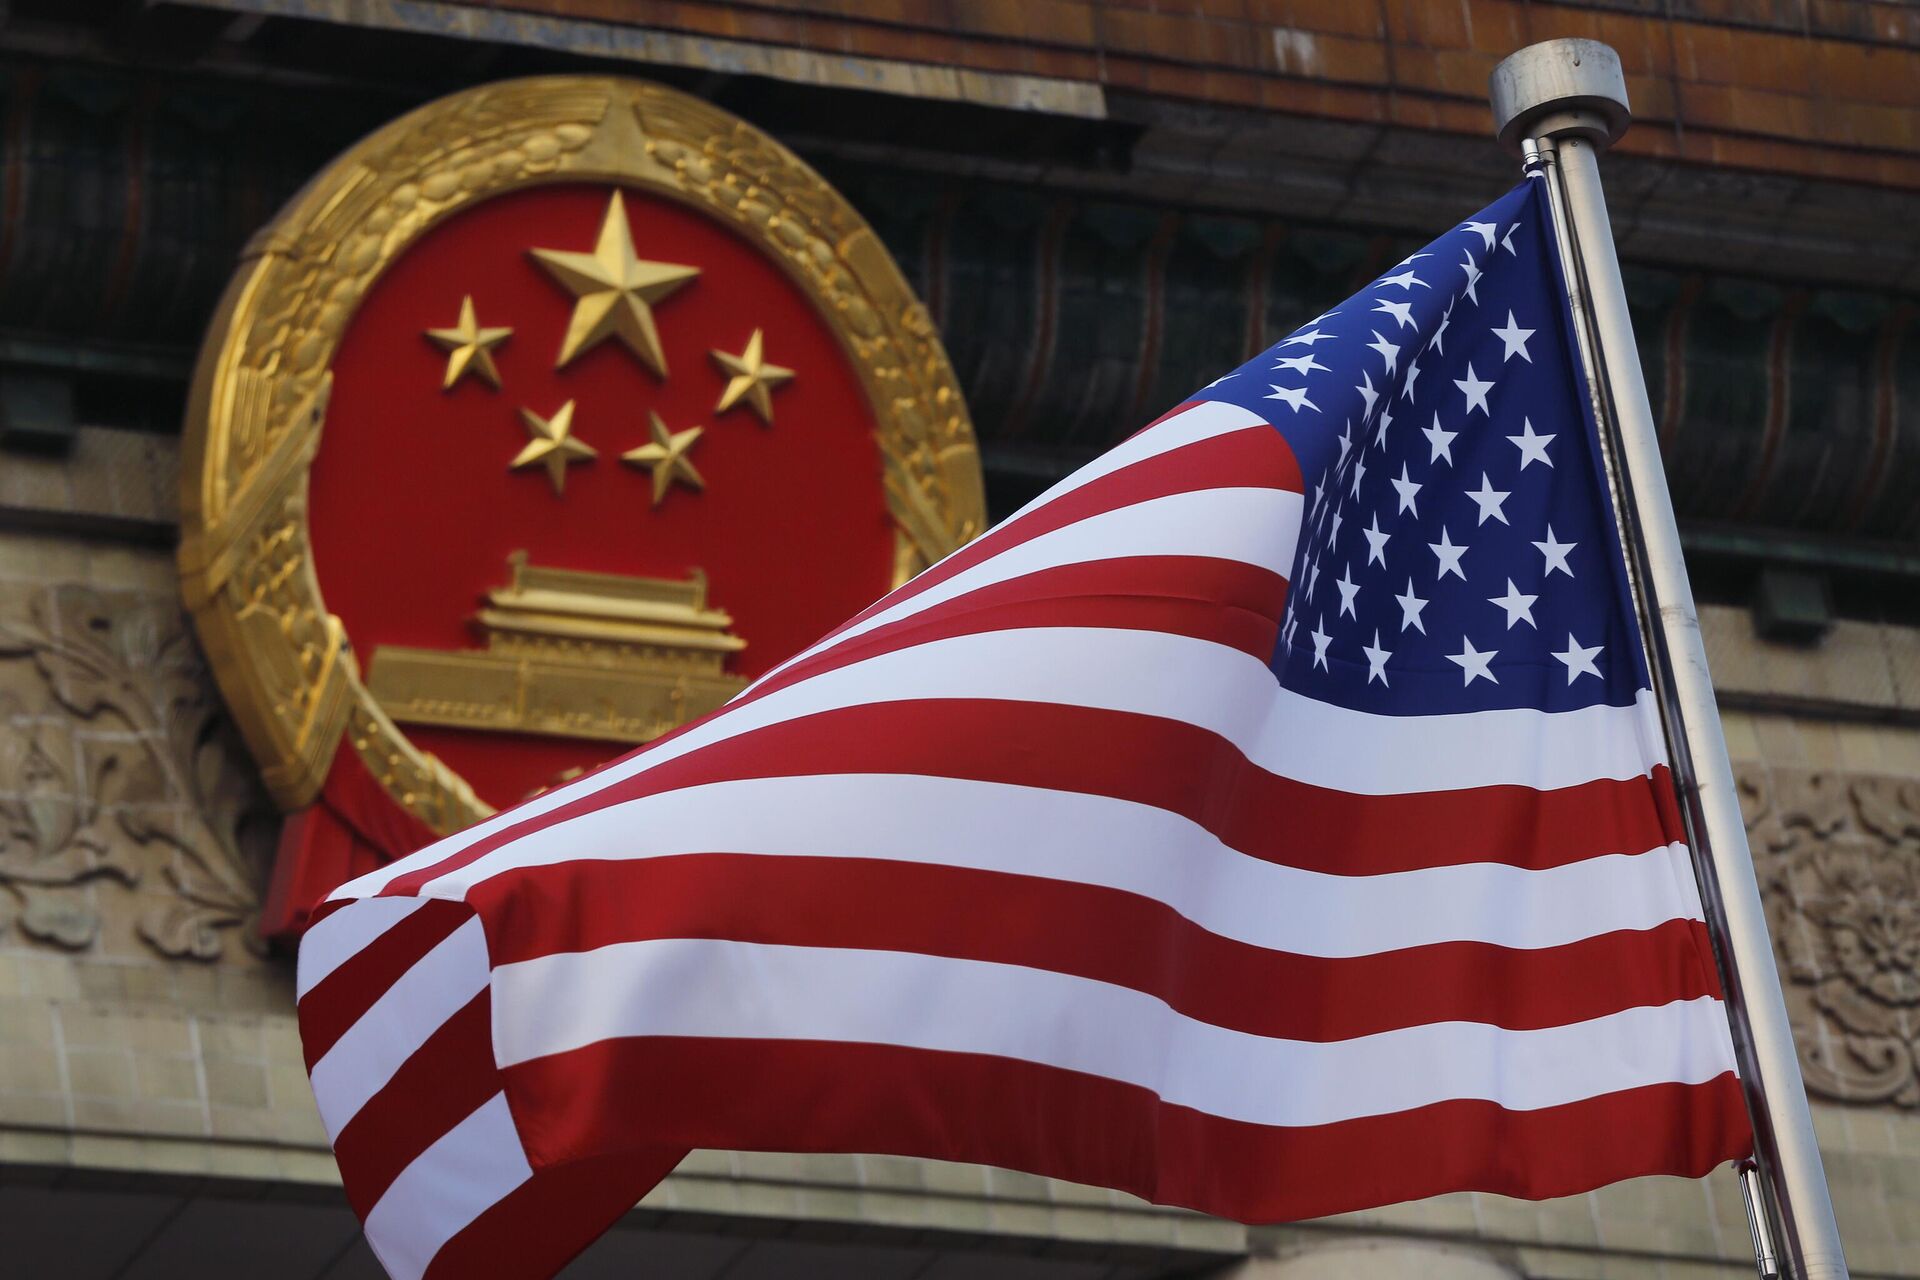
[179,77,985,833]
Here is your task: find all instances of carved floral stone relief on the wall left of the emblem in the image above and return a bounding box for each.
[0,583,278,960]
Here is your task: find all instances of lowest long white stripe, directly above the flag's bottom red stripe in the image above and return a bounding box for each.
[493,938,1734,1126]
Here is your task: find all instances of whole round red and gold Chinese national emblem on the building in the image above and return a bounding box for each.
[180,77,983,929]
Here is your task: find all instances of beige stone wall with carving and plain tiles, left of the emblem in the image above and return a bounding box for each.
[0,533,324,1176]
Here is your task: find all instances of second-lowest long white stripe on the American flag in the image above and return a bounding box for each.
[420,773,1699,958]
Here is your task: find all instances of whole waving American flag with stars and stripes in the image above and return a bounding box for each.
[298,182,1749,1280]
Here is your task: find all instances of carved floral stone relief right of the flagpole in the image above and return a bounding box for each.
[1740,768,1920,1107]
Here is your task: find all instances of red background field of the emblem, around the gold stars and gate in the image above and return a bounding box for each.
[309,184,895,806]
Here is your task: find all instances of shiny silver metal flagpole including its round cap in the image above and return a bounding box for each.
[1490,40,1847,1280]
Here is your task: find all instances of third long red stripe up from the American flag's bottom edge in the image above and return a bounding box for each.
[384,699,1676,894]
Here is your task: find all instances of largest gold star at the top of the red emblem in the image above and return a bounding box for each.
[532,192,701,378]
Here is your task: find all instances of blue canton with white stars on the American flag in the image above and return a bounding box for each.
[1200,180,1647,714]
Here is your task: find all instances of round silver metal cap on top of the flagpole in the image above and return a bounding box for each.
[1486,38,1634,154]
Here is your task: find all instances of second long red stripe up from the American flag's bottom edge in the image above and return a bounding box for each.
[468,850,1718,1040]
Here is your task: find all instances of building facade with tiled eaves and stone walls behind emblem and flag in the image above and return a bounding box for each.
[0,0,1920,1280]
